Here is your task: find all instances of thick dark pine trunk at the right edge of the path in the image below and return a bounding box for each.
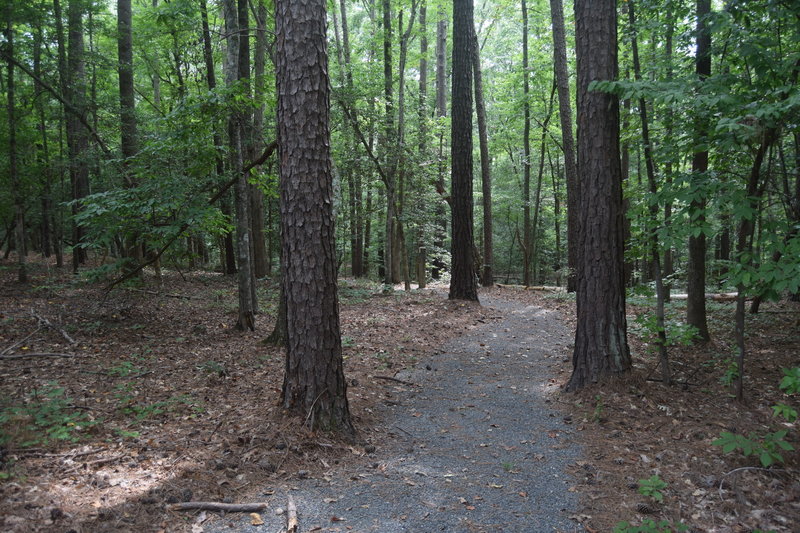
[566,0,631,391]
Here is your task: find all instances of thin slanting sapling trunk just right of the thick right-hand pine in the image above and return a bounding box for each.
[627,0,672,385]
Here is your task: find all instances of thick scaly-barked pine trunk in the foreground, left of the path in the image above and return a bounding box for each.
[275,0,355,435]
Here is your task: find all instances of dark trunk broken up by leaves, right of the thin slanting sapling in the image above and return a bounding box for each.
[686,0,711,341]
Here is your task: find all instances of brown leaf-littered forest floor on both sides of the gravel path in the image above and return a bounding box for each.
[0,256,800,533]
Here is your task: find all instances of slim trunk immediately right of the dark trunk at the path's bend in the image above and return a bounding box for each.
[472,27,494,287]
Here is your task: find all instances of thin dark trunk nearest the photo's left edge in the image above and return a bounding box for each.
[5,13,28,283]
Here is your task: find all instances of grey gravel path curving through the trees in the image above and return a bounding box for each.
[205,295,580,533]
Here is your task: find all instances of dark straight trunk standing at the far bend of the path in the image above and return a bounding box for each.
[449,0,478,301]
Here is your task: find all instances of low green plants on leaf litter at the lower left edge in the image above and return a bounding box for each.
[0,382,98,448]
